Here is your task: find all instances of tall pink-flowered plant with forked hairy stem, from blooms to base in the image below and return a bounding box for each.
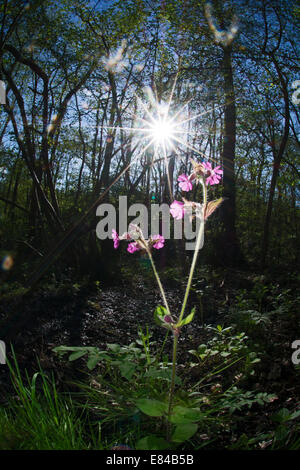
[112,159,223,444]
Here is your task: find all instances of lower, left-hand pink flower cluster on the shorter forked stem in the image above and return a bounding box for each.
[112,226,165,253]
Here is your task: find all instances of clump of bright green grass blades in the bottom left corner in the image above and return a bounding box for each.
[0,355,102,450]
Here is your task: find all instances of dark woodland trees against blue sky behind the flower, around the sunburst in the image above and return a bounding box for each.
[0,0,300,286]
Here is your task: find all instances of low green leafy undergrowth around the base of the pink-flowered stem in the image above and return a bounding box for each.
[55,322,273,450]
